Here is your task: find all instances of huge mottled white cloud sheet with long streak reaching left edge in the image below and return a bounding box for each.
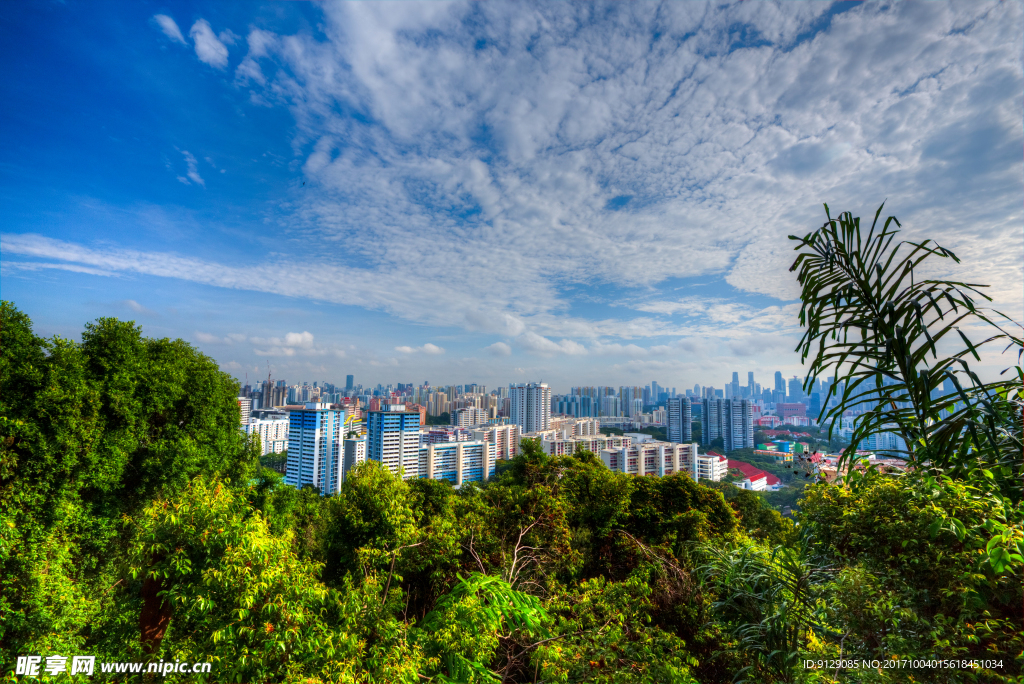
[9,2,1024,387]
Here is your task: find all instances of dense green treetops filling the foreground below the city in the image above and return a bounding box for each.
[0,201,1024,684]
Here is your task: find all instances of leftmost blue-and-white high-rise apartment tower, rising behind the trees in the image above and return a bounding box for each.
[285,403,344,495]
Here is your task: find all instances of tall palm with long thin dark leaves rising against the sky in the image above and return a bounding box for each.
[790,204,1024,502]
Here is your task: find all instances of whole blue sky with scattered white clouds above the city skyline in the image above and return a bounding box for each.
[0,1,1024,390]
